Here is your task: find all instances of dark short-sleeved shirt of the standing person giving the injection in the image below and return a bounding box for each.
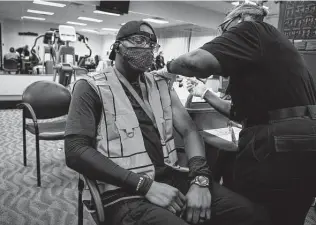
[201,21,316,123]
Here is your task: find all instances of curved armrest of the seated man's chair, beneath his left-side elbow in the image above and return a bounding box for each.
[83,175,105,223]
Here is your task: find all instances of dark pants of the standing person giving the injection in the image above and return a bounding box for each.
[234,118,316,225]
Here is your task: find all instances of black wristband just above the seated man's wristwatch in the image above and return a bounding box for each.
[188,156,212,181]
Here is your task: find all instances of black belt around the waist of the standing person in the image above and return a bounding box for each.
[243,105,316,127]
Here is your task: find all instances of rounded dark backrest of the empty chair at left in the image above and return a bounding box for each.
[22,80,71,119]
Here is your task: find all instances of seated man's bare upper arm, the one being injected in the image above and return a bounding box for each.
[170,89,197,136]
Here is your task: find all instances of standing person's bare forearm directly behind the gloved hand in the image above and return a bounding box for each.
[204,91,231,118]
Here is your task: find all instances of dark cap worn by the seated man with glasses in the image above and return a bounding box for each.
[109,20,157,60]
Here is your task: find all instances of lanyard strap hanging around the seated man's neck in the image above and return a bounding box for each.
[114,68,156,126]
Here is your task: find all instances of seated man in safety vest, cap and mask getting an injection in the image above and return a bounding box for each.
[65,21,269,225]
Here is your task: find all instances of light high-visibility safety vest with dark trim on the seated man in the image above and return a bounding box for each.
[78,67,180,204]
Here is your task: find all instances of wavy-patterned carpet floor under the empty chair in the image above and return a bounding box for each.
[0,110,316,225]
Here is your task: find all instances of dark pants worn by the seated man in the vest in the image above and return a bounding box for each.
[105,171,270,225]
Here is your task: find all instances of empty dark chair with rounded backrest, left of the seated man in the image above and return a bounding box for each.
[17,81,71,187]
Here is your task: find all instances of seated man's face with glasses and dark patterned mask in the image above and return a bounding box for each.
[120,35,159,72]
